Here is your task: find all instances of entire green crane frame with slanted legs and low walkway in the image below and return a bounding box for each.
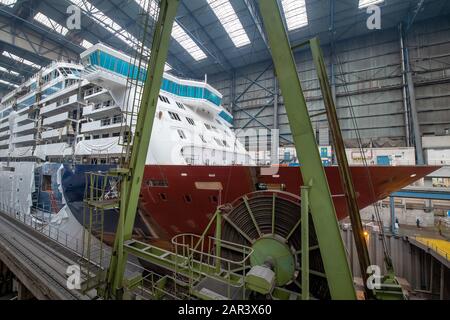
[104,0,404,300]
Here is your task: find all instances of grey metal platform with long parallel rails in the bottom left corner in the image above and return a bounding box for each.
[0,212,91,300]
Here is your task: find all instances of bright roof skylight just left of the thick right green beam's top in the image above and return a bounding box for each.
[206,0,250,48]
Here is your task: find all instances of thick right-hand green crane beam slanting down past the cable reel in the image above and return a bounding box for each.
[259,0,356,300]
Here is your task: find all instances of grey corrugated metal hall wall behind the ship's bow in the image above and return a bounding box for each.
[209,17,450,146]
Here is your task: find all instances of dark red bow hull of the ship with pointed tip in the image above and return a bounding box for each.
[140,165,438,239]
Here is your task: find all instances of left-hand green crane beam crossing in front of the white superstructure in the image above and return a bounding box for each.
[106,0,180,298]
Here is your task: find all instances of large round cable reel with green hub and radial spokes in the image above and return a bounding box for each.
[221,190,330,299]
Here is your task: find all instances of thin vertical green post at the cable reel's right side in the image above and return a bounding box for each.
[301,186,309,300]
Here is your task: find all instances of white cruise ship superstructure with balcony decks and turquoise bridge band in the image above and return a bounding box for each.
[0,44,250,165]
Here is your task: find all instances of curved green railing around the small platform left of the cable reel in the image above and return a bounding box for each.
[172,233,253,300]
